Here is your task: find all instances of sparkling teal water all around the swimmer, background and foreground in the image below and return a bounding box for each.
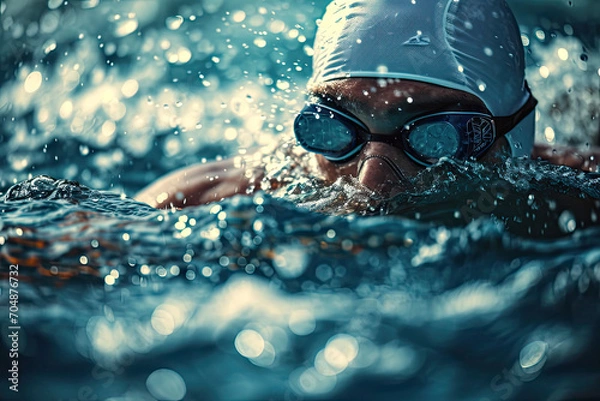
[0,1,600,401]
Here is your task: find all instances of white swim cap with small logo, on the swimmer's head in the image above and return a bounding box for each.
[308,0,535,156]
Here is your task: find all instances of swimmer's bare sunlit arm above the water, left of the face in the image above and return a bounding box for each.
[135,159,261,209]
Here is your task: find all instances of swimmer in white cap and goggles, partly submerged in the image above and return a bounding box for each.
[136,0,600,208]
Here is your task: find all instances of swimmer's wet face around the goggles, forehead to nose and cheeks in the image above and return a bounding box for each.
[313,78,508,198]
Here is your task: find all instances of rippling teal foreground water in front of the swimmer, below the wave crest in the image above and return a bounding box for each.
[0,173,600,399]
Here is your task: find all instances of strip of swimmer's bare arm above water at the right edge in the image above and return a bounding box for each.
[531,143,600,172]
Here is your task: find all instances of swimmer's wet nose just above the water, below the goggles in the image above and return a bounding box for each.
[358,143,413,198]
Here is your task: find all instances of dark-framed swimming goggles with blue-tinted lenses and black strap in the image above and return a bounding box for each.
[294,94,537,167]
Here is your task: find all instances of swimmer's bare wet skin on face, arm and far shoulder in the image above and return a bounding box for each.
[136,78,600,208]
